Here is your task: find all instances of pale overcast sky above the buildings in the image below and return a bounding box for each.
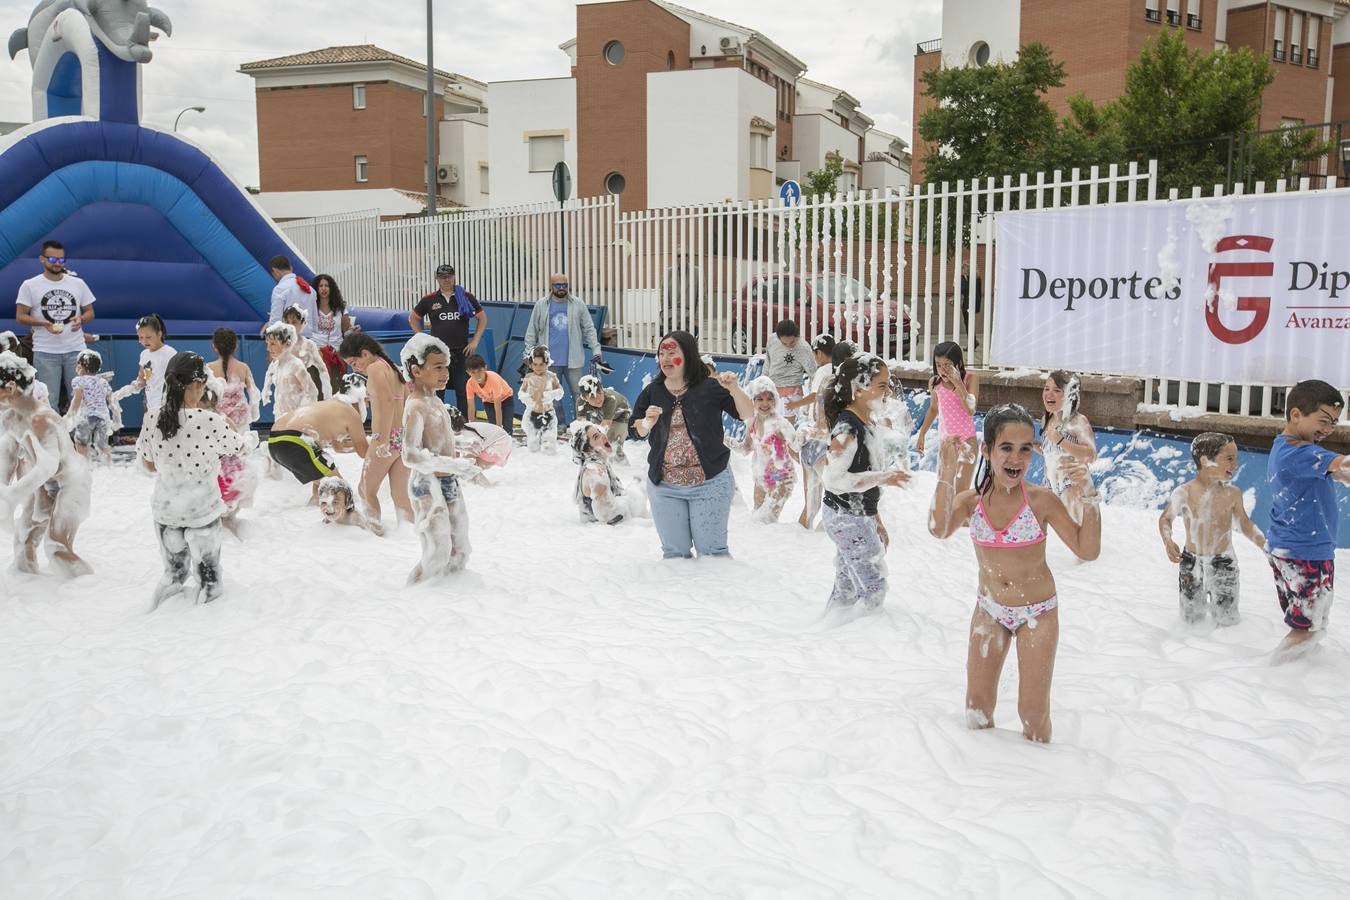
[0,0,942,185]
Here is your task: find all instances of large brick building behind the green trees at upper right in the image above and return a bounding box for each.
[913,0,1350,181]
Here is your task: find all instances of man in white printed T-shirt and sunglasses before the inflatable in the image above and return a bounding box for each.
[14,239,95,410]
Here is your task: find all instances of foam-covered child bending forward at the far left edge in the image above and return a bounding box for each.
[0,351,92,576]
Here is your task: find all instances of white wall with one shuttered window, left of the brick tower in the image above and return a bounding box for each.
[488,78,576,206]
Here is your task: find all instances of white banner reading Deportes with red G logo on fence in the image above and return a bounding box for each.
[991,189,1350,387]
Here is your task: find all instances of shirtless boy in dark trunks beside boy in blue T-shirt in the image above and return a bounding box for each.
[1158,432,1265,625]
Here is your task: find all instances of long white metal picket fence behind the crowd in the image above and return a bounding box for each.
[282,163,1328,417]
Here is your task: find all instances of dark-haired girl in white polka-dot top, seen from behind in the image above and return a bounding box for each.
[136,351,247,610]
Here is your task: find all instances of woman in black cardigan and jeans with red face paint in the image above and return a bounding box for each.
[633,331,755,559]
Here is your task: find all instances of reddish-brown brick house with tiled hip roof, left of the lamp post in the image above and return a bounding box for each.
[239,45,487,214]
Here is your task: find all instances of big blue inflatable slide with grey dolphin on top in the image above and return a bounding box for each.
[0,0,324,335]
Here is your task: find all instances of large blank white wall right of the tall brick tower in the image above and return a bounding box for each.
[648,69,775,206]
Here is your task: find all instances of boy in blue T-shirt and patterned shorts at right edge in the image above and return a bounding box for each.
[1266,381,1350,663]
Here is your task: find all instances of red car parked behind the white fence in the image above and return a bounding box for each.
[732,273,911,358]
